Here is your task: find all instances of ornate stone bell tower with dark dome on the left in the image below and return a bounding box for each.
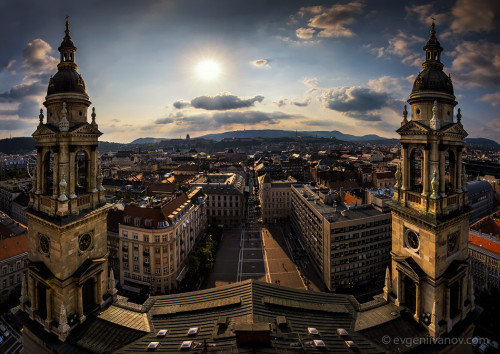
[21,21,113,340]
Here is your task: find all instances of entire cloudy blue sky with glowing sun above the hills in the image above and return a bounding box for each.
[0,0,500,143]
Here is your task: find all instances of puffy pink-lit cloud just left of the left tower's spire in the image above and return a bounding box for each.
[21,38,59,74]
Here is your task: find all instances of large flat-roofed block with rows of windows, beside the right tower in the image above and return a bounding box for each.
[291,184,391,293]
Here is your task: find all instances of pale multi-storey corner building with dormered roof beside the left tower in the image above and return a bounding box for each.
[118,187,207,294]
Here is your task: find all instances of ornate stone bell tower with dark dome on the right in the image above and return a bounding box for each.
[384,23,474,338]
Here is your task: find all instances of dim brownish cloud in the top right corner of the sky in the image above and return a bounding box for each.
[450,0,500,34]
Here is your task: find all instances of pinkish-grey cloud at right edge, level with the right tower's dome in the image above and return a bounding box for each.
[450,40,500,87]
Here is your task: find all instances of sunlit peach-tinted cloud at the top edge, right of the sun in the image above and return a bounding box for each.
[296,1,364,39]
